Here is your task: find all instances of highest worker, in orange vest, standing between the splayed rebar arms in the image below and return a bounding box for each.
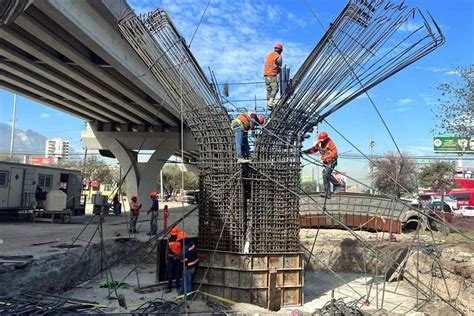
[263,43,283,110]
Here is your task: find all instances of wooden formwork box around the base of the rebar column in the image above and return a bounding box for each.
[193,250,304,308]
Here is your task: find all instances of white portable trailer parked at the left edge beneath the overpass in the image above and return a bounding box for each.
[0,161,82,212]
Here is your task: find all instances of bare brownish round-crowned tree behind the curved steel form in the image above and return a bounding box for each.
[370,152,417,198]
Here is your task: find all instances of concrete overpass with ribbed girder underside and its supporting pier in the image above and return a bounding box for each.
[0,0,196,202]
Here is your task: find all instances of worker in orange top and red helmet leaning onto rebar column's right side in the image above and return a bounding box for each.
[303,132,340,199]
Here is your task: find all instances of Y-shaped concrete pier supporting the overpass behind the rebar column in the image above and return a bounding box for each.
[82,124,196,210]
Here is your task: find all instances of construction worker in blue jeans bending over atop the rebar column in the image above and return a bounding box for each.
[231,112,265,163]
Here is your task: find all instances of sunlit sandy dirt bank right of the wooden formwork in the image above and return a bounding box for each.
[300,229,474,315]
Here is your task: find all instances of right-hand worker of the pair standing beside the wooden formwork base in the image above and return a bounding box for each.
[176,231,199,300]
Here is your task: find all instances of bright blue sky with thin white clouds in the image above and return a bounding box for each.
[0,0,474,186]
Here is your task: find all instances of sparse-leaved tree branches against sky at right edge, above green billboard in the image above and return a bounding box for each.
[435,65,474,138]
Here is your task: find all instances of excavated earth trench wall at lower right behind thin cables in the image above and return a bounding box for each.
[301,230,474,315]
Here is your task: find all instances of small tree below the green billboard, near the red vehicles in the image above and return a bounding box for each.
[418,161,455,191]
